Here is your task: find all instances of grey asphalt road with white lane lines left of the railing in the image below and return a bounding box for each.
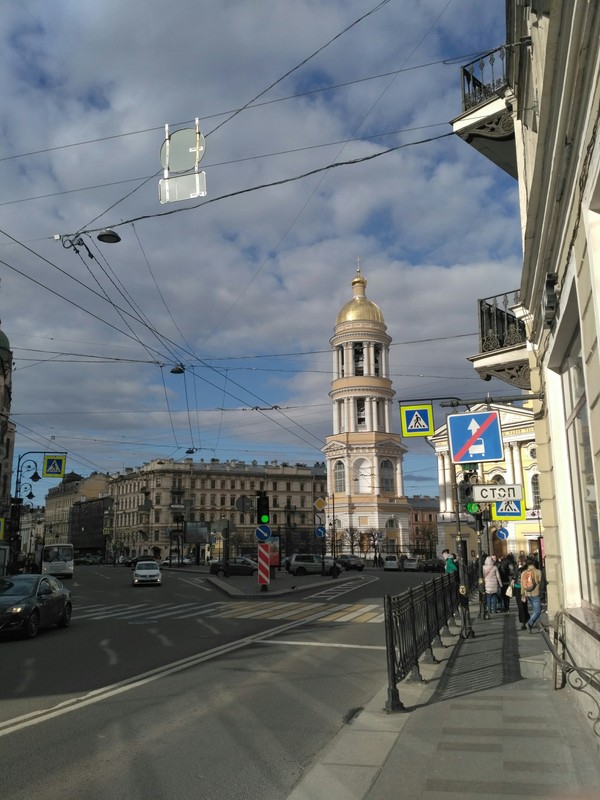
[0,567,432,800]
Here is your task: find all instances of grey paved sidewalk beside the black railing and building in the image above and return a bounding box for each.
[288,604,600,800]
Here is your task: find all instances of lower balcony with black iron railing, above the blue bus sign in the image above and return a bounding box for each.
[468,291,531,391]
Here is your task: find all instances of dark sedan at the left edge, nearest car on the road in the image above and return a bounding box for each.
[0,573,73,639]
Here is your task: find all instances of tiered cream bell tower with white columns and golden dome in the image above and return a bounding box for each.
[323,268,410,553]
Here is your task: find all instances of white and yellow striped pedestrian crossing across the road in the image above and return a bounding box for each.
[73,601,384,623]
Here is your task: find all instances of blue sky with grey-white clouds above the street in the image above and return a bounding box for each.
[0,0,521,495]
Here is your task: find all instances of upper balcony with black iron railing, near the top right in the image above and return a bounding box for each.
[451,47,517,178]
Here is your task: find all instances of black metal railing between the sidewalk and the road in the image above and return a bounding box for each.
[384,565,477,711]
